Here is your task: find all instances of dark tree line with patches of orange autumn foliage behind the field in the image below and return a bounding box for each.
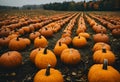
[43,0,120,11]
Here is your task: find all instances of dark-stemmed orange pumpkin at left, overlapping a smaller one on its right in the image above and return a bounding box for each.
[9,37,26,50]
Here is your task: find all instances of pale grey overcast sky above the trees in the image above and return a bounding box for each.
[0,0,89,7]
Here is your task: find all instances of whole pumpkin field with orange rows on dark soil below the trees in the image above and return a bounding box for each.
[0,10,120,82]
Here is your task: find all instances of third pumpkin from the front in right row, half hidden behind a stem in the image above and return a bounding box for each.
[92,42,111,52]
